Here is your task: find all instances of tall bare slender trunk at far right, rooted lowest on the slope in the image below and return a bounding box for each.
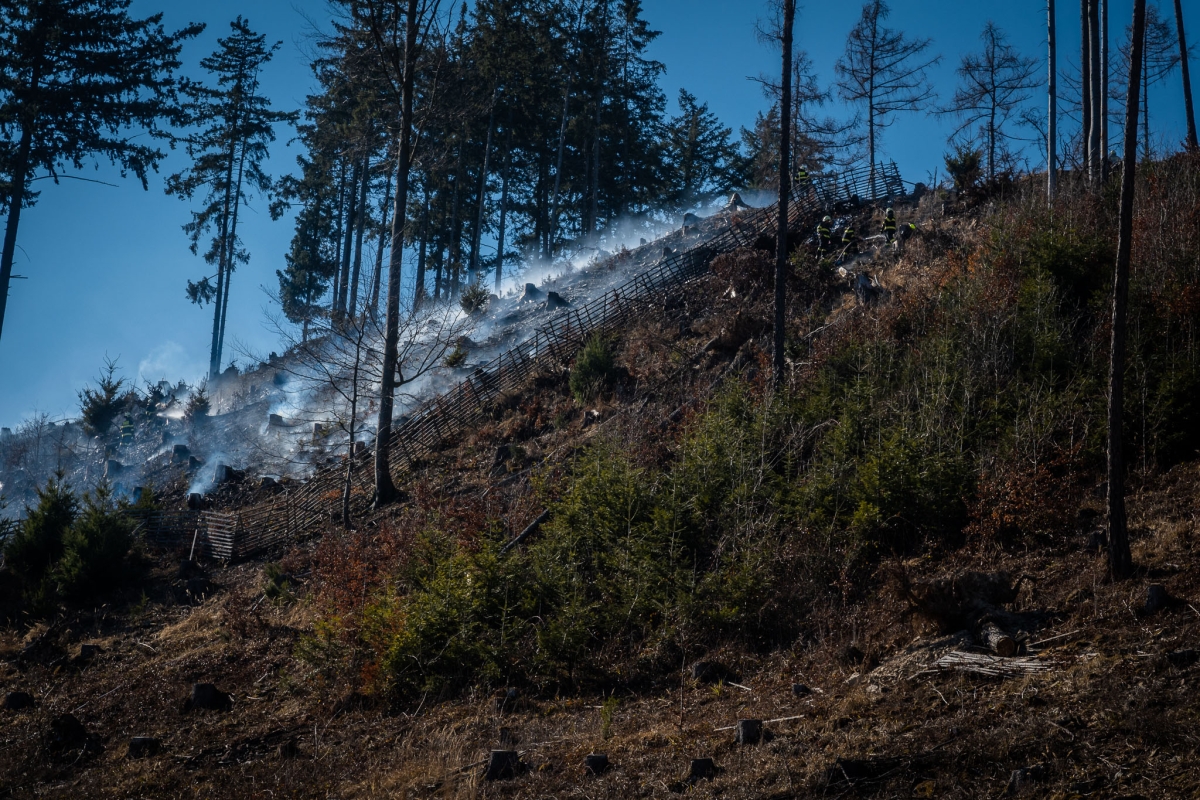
[1108,0,1146,578]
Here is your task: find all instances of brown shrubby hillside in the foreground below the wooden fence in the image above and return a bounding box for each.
[0,156,1200,798]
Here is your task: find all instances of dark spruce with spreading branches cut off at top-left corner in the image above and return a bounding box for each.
[0,0,204,345]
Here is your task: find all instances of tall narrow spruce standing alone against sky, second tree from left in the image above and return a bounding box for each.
[167,17,296,378]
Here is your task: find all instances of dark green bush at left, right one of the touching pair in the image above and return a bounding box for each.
[54,483,133,600]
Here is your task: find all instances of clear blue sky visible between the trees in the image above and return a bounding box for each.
[0,0,1200,427]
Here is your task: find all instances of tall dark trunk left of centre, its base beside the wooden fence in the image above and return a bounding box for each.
[374,0,418,506]
